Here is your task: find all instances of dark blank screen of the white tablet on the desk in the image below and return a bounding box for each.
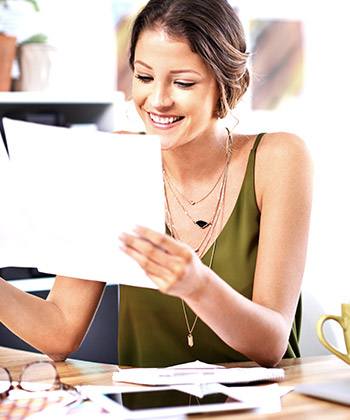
[105,390,236,410]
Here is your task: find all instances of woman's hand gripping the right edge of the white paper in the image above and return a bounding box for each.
[120,227,209,299]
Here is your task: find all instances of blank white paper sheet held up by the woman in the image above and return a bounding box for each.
[0,118,165,288]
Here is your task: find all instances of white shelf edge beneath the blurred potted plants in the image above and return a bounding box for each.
[0,91,123,105]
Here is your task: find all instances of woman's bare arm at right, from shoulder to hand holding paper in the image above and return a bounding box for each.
[122,133,312,366]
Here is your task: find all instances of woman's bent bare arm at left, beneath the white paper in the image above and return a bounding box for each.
[0,277,105,361]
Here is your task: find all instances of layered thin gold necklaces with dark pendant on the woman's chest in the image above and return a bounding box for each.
[163,128,232,347]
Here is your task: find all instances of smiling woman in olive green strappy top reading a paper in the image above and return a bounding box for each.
[0,0,311,366]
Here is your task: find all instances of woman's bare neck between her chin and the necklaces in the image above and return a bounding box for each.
[162,127,227,184]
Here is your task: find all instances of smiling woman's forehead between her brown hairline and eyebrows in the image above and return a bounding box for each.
[135,29,209,74]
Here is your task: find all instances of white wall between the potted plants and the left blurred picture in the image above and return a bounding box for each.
[39,0,116,94]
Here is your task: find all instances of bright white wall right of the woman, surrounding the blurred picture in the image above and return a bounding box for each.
[232,0,350,355]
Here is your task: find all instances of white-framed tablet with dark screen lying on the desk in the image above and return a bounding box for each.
[83,389,256,419]
